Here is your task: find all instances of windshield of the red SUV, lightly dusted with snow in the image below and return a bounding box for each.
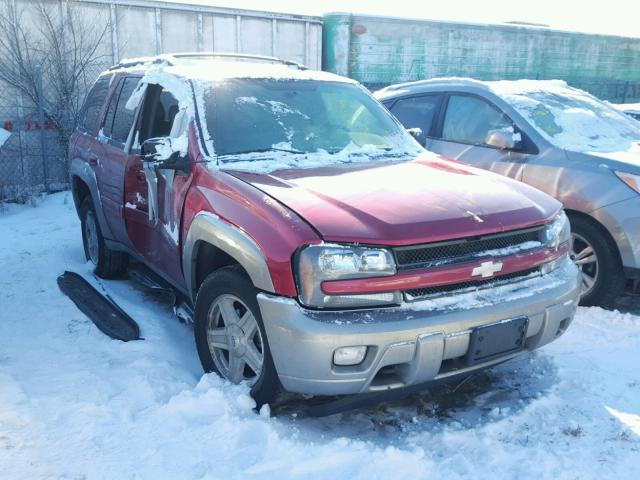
[204,79,417,161]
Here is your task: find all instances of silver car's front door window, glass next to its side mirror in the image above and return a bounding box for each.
[442,95,513,145]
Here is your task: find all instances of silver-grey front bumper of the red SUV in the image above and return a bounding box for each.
[258,259,580,395]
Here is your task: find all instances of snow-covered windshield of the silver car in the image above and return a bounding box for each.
[487,80,640,152]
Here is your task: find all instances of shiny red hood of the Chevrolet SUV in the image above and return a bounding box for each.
[228,154,561,245]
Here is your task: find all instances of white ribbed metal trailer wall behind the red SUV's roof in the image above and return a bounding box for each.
[75,0,322,68]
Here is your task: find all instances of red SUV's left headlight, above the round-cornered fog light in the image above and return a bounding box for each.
[296,245,400,308]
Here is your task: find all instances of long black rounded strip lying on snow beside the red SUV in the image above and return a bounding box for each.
[58,272,140,342]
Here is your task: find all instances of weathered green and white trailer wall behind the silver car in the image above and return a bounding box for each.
[324,14,640,101]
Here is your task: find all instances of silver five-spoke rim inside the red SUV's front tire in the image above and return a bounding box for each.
[207,294,264,386]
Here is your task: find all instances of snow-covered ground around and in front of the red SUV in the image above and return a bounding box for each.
[0,193,640,480]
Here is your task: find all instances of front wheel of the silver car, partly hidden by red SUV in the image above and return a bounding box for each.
[570,216,625,308]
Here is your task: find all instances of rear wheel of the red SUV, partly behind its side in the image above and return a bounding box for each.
[80,197,128,278]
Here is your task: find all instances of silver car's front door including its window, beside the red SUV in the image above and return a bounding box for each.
[429,93,537,180]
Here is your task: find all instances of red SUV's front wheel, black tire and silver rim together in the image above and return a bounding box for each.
[194,266,280,408]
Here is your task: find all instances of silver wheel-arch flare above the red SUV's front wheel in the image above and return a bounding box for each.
[182,212,275,302]
